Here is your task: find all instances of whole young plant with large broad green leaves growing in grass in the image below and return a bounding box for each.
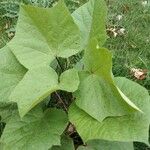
[0,0,150,150]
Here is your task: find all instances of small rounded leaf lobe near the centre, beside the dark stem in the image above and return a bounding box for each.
[59,69,79,92]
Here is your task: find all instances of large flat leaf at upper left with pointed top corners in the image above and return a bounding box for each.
[9,0,81,69]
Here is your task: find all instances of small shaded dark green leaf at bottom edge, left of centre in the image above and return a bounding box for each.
[51,135,74,150]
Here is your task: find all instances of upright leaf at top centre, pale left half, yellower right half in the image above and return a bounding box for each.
[72,0,107,48]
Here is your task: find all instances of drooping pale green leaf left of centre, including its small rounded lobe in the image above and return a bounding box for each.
[10,66,79,117]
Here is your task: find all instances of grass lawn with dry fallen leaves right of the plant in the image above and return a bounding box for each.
[105,0,150,92]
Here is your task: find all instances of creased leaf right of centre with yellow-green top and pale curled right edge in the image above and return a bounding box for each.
[75,40,141,122]
